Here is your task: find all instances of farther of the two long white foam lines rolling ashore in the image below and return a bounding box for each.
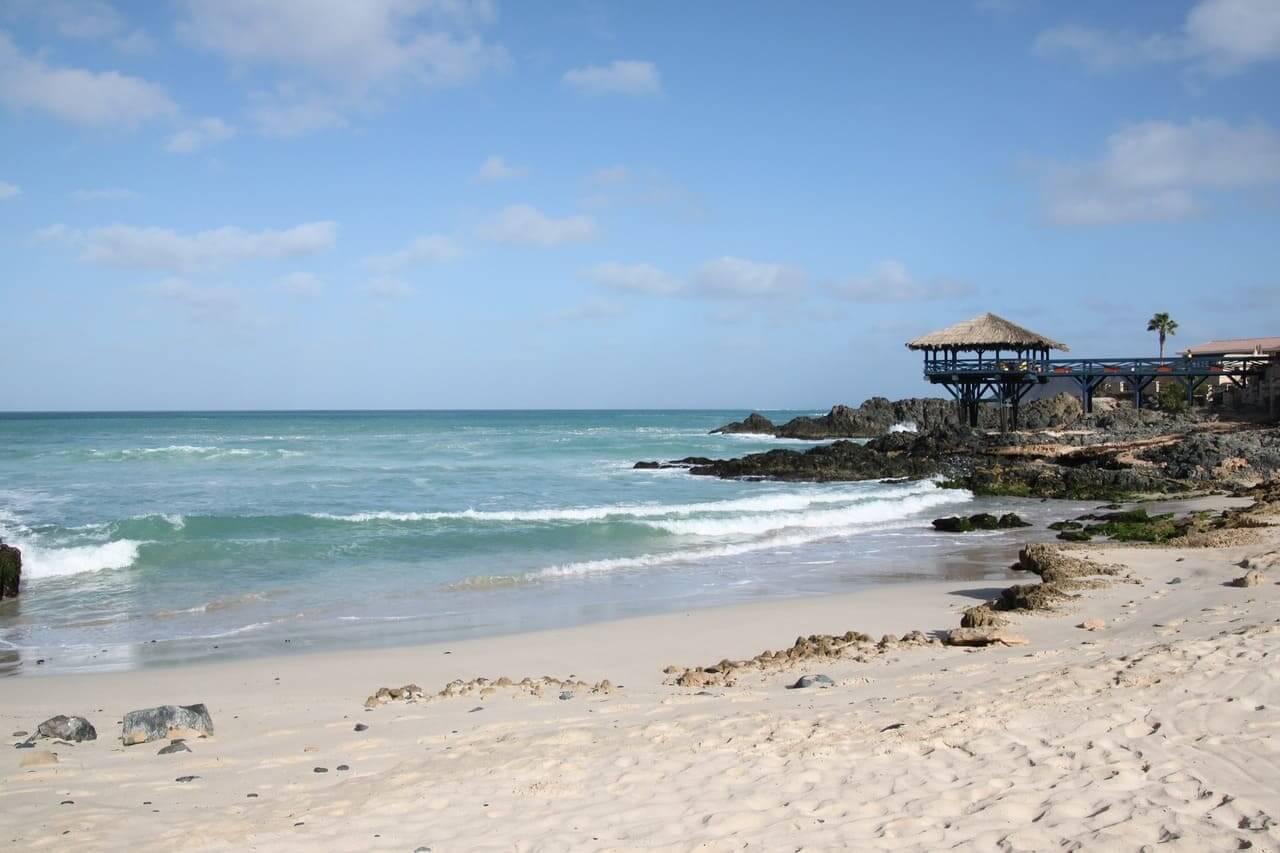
[310,480,937,523]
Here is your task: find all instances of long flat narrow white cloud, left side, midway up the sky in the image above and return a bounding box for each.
[37,222,338,270]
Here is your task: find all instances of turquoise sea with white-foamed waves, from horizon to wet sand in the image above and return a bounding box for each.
[0,411,1044,671]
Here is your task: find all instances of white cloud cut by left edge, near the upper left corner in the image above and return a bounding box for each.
[0,32,177,127]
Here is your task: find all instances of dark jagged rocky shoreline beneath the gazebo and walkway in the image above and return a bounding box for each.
[636,394,1280,501]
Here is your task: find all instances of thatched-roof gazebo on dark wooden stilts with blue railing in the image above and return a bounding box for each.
[906,314,1068,428]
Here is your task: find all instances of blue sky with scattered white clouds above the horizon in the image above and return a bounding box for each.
[0,0,1280,411]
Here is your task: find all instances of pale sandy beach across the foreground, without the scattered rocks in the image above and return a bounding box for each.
[0,517,1280,852]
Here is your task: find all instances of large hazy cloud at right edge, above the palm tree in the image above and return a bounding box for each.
[1043,119,1280,225]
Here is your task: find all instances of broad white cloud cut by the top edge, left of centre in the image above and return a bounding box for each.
[178,0,507,91]
